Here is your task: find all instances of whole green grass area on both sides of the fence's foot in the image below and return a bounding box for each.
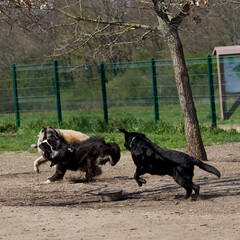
[0,104,240,151]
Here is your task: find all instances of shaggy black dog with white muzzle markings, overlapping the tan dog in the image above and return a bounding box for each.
[39,133,120,182]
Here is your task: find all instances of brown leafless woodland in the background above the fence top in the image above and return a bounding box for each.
[0,0,240,66]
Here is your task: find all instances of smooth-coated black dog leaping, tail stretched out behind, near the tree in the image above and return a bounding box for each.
[119,129,220,199]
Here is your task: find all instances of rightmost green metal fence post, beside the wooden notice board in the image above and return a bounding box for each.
[207,55,217,127]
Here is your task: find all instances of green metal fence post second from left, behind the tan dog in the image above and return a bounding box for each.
[53,60,62,128]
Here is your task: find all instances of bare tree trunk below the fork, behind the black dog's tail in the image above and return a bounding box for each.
[158,18,207,160]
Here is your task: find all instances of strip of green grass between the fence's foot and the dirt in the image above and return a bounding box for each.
[0,115,240,151]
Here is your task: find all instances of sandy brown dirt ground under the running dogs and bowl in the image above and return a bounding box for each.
[0,142,240,240]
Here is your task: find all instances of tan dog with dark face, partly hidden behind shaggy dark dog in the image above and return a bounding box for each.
[34,125,89,173]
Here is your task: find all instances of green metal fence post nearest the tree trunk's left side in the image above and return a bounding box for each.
[151,58,159,123]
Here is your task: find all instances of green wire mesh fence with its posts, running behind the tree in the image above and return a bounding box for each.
[0,56,240,127]
